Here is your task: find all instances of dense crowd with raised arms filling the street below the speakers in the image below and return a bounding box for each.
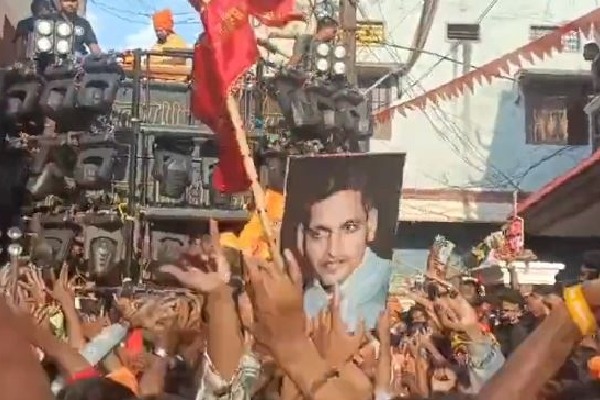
[0,216,600,400]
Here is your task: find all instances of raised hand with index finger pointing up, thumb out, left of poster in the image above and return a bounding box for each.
[159,220,231,293]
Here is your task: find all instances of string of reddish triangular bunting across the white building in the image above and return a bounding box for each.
[373,9,600,122]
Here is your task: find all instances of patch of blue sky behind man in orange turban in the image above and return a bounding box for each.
[86,0,201,50]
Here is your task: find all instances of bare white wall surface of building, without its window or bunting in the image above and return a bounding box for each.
[358,0,598,195]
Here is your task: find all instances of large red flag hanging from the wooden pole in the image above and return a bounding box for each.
[192,0,258,193]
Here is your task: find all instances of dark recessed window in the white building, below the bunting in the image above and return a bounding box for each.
[525,90,589,145]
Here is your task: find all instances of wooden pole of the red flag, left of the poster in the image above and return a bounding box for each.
[227,92,284,270]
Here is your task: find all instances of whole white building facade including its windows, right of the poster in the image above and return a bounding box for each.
[357,0,598,270]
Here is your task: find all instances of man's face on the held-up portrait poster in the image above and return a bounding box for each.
[298,190,377,286]
